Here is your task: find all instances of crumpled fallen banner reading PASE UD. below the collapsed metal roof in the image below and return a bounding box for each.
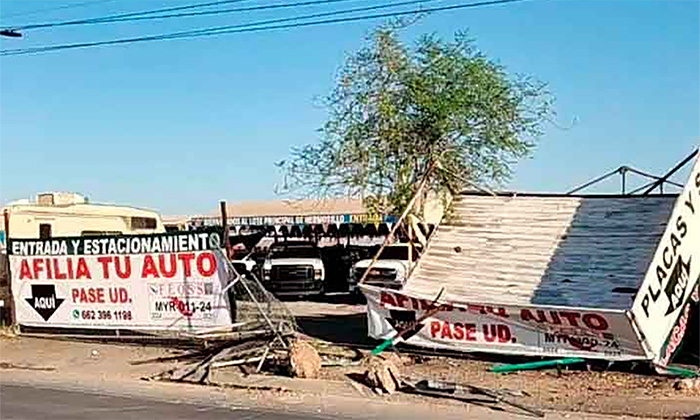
[361,286,646,360]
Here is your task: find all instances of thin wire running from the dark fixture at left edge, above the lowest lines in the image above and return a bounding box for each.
[8,0,355,31]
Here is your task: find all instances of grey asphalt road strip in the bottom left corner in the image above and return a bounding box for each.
[0,384,322,420]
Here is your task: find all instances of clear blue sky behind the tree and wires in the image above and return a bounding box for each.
[0,0,700,214]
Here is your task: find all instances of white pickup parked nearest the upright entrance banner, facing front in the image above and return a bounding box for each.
[263,241,326,296]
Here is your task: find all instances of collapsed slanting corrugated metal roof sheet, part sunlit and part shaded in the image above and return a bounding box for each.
[405,194,675,309]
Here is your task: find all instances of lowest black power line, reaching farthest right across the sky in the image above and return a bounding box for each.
[0,0,526,55]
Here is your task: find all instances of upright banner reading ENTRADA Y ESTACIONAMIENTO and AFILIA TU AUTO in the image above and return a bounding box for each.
[8,232,232,332]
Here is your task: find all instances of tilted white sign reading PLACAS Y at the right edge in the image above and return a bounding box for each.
[632,150,700,365]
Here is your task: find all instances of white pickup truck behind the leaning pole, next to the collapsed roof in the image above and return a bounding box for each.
[348,243,420,293]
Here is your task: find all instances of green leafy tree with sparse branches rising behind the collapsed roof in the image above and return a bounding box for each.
[280,27,553,217]
